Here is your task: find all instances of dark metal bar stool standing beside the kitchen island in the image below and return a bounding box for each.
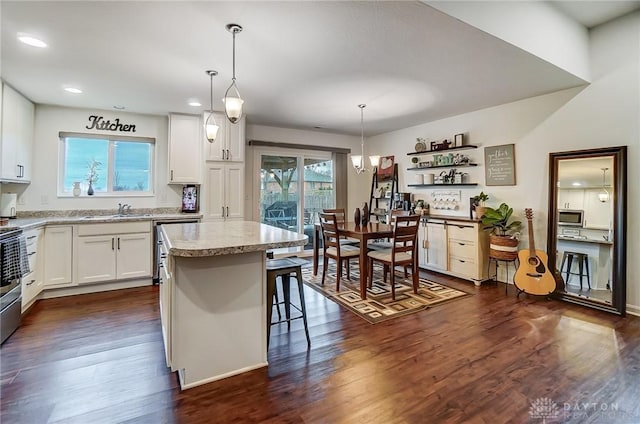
[266,258,311,348]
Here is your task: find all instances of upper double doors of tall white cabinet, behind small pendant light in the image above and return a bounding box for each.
[202,112,246,162]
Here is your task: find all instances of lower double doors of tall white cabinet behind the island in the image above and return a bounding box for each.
[204,162,244,221]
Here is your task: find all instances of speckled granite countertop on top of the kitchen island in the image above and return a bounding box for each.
[162,221,308,257]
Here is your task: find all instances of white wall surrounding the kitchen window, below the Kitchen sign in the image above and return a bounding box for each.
[2,105,182,211]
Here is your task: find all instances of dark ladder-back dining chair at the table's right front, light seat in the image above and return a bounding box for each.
[367,215,420,300]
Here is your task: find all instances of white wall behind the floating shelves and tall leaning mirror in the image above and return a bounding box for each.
[370,12,640,313]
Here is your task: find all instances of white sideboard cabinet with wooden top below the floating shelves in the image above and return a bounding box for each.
[419,219,489,285]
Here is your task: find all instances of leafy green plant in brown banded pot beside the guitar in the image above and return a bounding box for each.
[482,203,522,261]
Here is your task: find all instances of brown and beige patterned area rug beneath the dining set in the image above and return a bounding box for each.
[302,264,469,324]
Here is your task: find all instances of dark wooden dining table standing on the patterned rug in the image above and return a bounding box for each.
[313,222,393,299]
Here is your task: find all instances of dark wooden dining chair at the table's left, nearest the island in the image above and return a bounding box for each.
[319,213,360,291]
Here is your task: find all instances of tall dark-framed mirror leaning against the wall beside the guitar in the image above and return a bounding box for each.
[547,146,627,315]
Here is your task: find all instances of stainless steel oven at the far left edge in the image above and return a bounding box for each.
[0,229,29,343]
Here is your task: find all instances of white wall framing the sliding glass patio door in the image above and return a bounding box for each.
[245,125,362,219]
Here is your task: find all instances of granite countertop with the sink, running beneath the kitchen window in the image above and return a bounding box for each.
[0,213,202,232]
